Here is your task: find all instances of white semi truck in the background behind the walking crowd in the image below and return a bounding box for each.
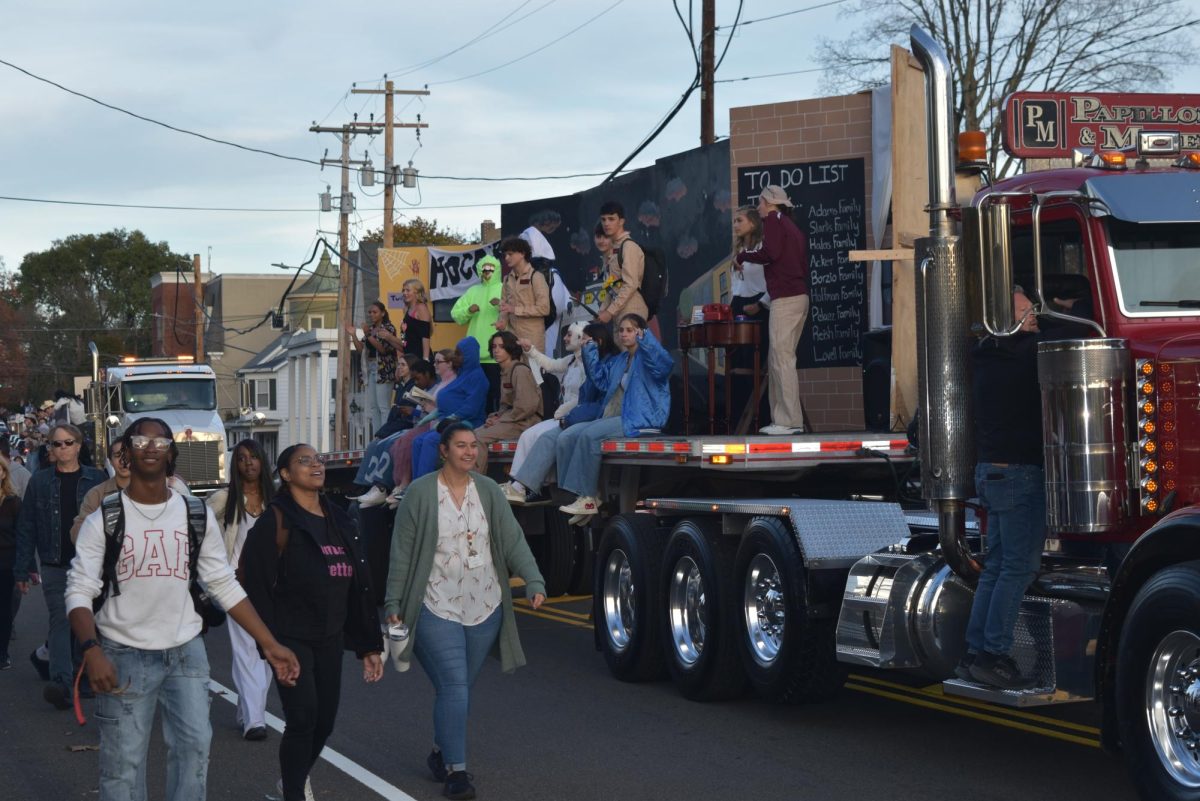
[86,344,228,495]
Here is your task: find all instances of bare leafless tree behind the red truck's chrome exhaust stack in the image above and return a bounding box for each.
[821,0,1200,176]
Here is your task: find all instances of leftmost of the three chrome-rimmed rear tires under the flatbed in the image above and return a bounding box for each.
[592,514,666,681]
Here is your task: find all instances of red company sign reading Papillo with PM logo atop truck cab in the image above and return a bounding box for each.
[1003,92,1200,158]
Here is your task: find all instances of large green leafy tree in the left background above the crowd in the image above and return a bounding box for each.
[18,229,191,397]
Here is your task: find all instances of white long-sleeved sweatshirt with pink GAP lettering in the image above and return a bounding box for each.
[66,490,246,651]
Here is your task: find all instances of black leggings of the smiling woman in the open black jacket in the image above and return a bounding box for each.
[275,634,342,801]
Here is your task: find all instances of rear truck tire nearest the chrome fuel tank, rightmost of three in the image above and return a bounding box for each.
[733,517,846,704]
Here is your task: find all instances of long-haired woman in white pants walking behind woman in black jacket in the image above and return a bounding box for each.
[206,439,275,740]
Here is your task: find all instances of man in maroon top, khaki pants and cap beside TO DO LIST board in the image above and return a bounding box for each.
[736,185,809,435]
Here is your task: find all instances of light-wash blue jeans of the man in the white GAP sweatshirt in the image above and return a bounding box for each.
[95,637,212,801]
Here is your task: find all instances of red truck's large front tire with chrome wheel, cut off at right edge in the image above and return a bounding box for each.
[1115,562,1200,801]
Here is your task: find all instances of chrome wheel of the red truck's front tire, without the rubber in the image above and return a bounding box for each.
[1146,631,1200,789]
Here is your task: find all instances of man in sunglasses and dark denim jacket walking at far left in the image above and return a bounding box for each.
[13,423,106,710]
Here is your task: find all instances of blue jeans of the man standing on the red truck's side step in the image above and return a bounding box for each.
[966,463,1046,655]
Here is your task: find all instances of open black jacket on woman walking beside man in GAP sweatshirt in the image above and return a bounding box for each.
[239,492,383,658]
